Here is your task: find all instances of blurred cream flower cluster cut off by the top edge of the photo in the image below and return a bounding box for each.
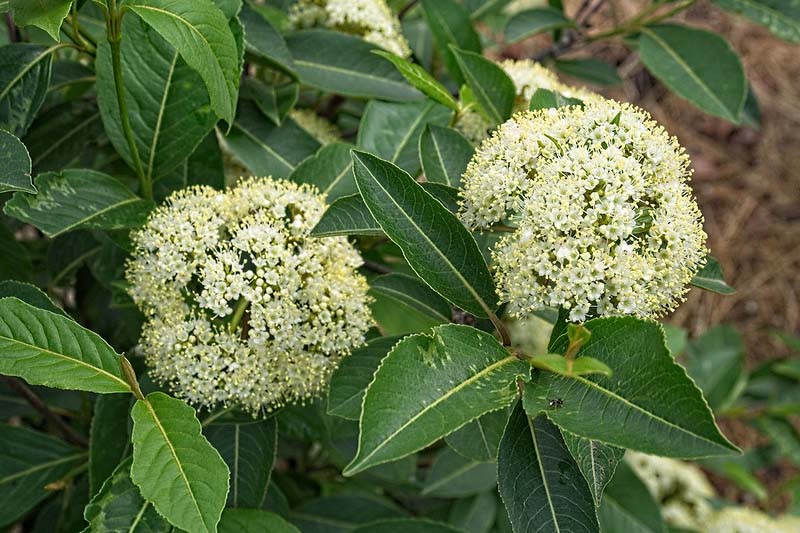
[289,0,411,57]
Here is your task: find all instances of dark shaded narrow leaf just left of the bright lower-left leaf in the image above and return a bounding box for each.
[89,394,132,496]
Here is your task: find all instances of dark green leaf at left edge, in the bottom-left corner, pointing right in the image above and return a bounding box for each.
[0,422,86,527]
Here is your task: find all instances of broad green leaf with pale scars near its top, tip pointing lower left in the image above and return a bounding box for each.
[343,324,529,476]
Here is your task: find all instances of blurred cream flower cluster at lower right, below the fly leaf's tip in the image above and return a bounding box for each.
[625,450,716,529]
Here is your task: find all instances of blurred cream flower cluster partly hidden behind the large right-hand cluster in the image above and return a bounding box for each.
[455,59,601,143]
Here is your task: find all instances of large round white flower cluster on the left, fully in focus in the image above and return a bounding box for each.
[126,178,372,414]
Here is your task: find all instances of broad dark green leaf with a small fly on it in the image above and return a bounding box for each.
[524,317,738,458]
